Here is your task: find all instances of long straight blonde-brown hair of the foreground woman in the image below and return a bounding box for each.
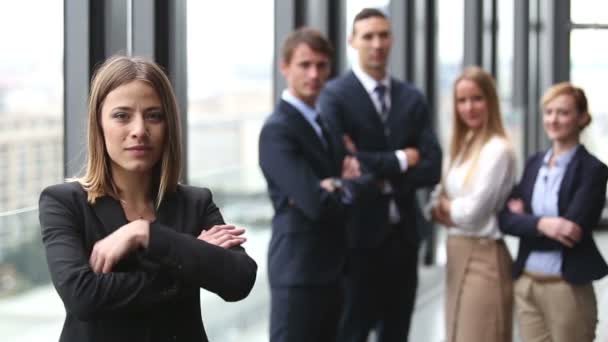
[76,56,181,208]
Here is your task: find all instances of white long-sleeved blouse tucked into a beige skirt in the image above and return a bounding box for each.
[444,136,515,239]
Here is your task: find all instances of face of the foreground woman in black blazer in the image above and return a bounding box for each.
[101,81,167,173]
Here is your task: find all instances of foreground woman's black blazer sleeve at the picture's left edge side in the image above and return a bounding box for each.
[39,188,177,320]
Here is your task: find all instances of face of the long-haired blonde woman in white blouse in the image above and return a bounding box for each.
[456,79,488,130]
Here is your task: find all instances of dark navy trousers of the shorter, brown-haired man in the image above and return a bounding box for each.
[270,283,343,342]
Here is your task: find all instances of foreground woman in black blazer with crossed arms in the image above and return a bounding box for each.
[40,57,257,342]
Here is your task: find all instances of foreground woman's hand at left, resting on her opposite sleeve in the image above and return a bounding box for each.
[89,220,150,273]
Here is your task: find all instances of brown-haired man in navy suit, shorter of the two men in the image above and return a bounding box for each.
[259,28,376,342]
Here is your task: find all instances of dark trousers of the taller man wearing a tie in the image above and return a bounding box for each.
[338,228,418,342]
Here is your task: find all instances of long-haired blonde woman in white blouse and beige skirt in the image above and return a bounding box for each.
[432,67,515,342]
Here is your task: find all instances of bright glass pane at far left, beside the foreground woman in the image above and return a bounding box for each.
[0,0,63,341]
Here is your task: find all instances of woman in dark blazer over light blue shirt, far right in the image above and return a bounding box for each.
[499,82,608,342]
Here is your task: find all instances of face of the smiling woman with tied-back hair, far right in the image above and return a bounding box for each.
[543,94,585,142]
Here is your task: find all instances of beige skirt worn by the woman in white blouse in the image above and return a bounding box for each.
[446,236,513,342]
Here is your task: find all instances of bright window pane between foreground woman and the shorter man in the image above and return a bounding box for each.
[186,0,274,341]
